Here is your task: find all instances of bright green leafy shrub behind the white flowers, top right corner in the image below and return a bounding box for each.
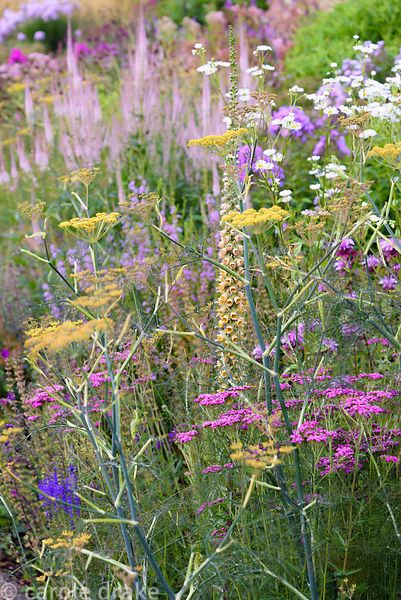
[286,0,401,79]
